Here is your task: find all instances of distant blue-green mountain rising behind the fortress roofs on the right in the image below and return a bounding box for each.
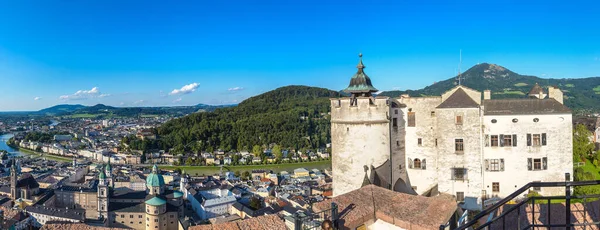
[379,63,600,114]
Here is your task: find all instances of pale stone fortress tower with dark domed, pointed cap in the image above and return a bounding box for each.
[331,55,405,196]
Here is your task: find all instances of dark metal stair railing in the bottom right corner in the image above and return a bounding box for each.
[448,173,600,230]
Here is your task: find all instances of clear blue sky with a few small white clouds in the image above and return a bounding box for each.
[0,0,600,111]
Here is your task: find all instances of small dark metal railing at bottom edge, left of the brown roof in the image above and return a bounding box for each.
[293,203,339,230]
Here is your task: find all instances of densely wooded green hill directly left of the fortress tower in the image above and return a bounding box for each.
[158,86,340,153]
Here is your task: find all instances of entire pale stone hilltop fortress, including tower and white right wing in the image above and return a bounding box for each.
[331,56,573,209]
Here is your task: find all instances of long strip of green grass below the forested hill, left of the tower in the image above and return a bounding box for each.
[159,160,331,176]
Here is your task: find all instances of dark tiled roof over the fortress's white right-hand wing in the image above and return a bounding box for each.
[483,98,571,115]
